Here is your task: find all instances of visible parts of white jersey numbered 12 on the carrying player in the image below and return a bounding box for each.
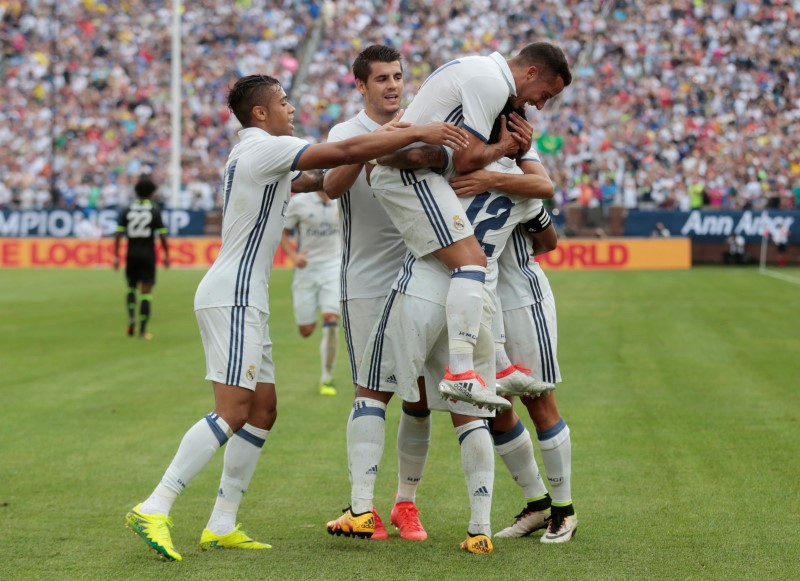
[392,158,542,305]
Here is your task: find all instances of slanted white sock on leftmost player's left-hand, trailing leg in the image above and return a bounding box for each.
[142,412,232,516]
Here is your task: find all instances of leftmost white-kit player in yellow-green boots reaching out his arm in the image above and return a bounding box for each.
[125,75,467,561]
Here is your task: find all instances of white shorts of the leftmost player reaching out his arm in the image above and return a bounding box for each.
[195,307,275,390]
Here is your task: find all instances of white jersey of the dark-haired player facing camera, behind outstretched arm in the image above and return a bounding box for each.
[328,111,406,301]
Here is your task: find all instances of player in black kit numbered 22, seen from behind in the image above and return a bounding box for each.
[114,176,169,339]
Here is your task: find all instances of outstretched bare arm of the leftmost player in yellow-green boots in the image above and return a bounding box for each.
[295,121,469,170]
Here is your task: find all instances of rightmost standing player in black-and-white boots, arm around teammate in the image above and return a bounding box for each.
[451,134,578,543]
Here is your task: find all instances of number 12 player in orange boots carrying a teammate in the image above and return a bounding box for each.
[327,123,552,553]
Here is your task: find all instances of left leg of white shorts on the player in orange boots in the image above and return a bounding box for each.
[357,291,446,402]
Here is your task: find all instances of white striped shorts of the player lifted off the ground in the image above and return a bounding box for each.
[375,171,473,257]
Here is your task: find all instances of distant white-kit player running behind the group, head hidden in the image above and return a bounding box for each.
[281,191,342,395]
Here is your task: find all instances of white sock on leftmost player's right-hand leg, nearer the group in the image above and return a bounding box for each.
[206,424,269,535]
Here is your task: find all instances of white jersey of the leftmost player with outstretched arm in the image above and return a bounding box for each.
[194,127,310,313]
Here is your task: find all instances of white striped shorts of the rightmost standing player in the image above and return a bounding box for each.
[503,293,561,383]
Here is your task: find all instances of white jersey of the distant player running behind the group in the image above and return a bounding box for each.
[283,192,342,268]
